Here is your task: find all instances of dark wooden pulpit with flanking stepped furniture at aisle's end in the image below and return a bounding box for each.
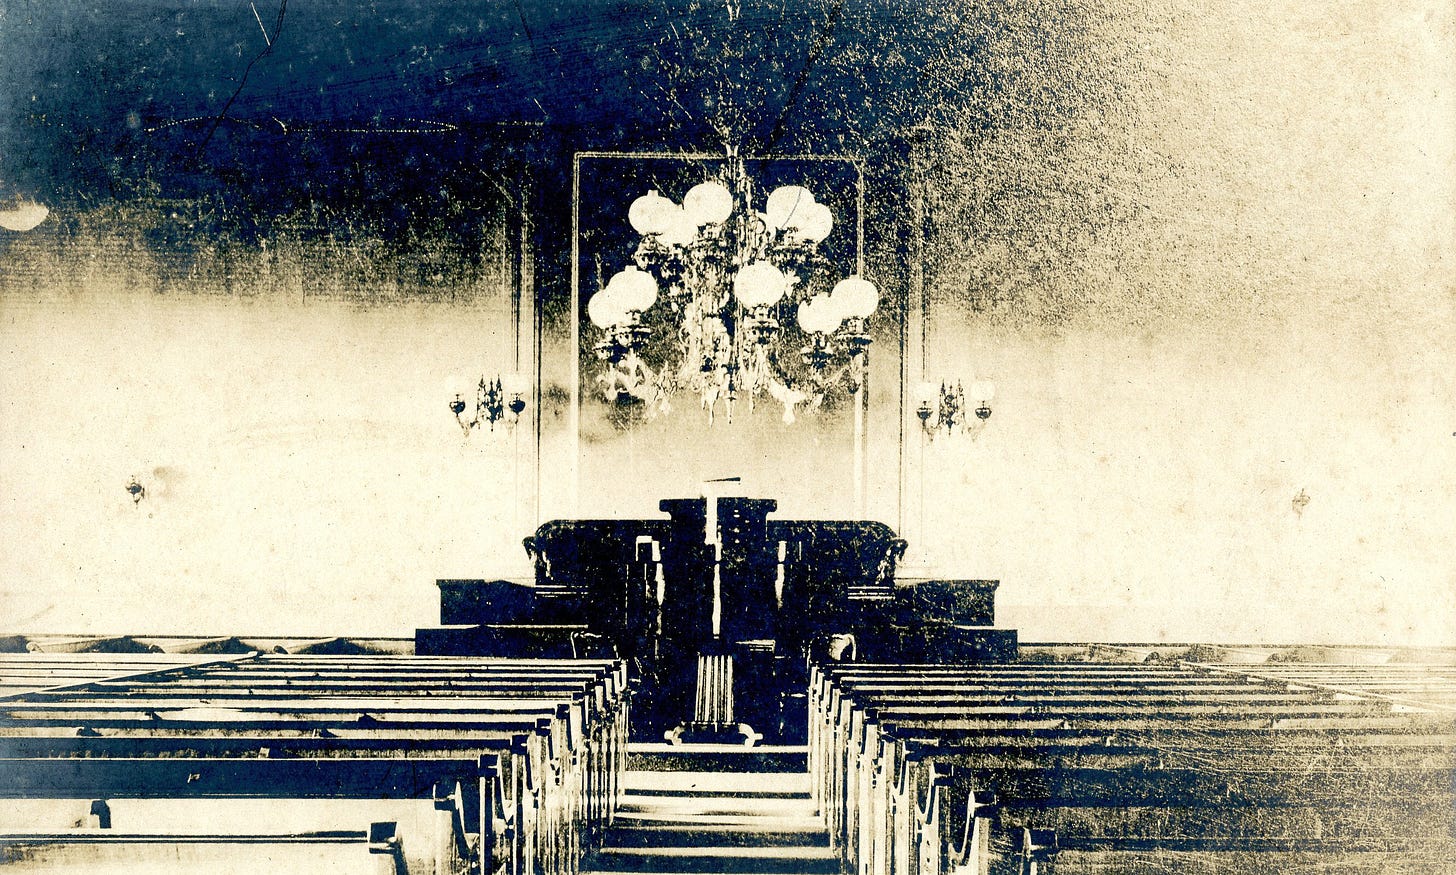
[415,498,1016,744]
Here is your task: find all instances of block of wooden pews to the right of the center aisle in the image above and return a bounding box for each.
[810,664,1456,875]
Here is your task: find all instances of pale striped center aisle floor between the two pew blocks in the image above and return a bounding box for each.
[582,748,839,875]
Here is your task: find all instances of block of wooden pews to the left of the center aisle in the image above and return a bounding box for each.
[0,655,628,875]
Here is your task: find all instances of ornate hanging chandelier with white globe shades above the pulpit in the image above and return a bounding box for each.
[587,156,879,424]
